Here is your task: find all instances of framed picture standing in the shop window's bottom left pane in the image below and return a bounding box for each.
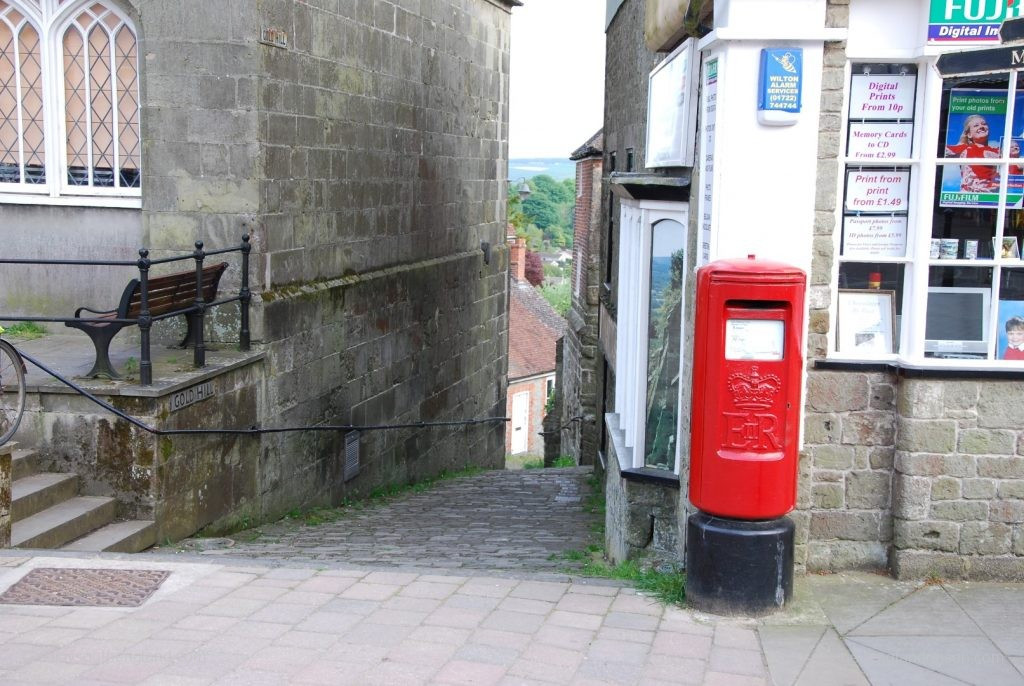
[836,289,896,355]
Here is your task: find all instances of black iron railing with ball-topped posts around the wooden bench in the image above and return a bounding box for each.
[0,233,252,386]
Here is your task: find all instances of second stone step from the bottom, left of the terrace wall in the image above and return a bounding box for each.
[10,496,117,548]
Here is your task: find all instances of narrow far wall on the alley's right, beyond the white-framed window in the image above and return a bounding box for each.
[558,157,602,465]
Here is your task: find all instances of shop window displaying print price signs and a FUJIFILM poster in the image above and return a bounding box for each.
[833,62,1024,367]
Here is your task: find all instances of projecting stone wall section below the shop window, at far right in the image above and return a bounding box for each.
[893,379,1024,582]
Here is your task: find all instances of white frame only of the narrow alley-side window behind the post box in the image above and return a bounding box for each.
[614,200,689,475]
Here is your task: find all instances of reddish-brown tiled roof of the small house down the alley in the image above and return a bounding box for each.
[509,278,565,380]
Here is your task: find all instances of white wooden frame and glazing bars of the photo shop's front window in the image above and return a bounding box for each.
[827,54,1024,371]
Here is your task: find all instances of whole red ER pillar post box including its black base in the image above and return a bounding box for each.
[687,256,807,614]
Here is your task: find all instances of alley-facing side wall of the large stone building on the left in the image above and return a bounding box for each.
[248,0,509,515]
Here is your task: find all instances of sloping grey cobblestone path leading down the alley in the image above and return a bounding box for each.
[166,467,601,572]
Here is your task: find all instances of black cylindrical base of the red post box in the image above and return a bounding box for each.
[686,512,795,615]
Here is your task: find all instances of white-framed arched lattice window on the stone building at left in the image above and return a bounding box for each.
[0,0,141,204]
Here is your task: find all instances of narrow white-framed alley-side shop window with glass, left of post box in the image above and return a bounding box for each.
[614,201,686,471]
